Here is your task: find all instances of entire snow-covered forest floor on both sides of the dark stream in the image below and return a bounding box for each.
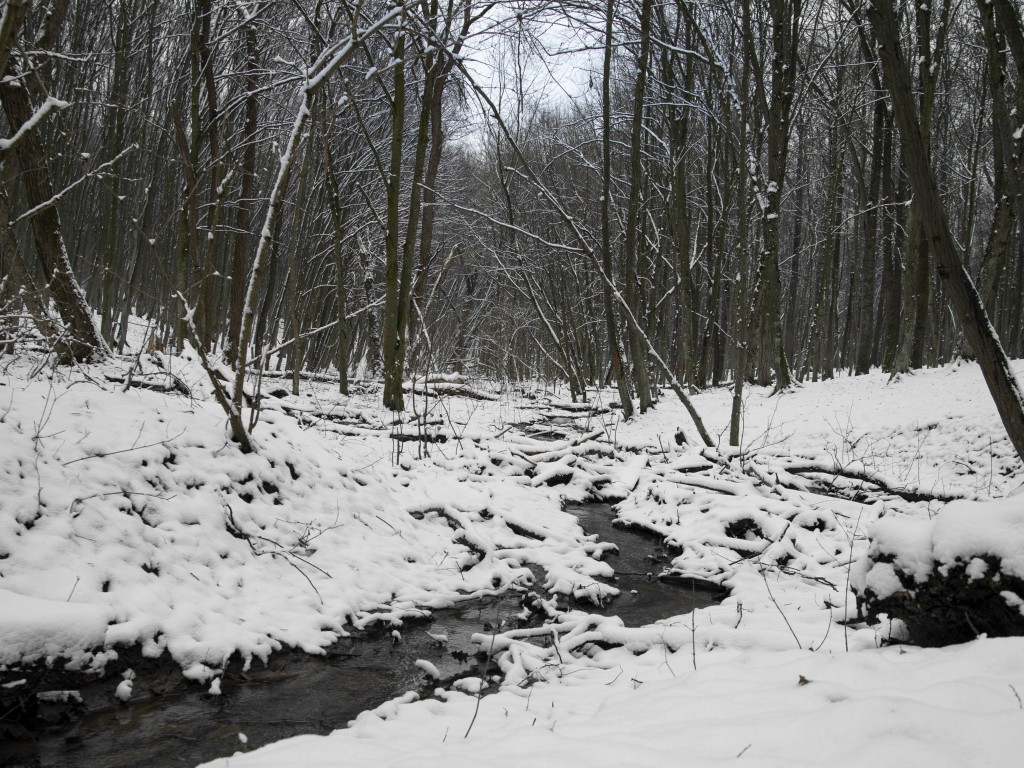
[0,355,1024,768]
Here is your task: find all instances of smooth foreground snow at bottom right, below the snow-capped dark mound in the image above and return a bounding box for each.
[197,639,1024,768]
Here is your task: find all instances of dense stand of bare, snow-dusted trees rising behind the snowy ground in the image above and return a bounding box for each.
[0,0,1024,450]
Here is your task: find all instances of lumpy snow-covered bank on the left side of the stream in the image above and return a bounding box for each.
[0,357,607,680]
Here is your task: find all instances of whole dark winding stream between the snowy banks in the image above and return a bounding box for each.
[0,503,722,768]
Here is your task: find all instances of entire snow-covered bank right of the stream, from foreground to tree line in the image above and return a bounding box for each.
[193,366,1024,768]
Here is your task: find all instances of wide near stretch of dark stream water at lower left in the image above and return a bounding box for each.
[0,593,522,768]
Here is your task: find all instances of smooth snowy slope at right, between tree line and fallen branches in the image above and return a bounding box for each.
[688,360,1024,499]
